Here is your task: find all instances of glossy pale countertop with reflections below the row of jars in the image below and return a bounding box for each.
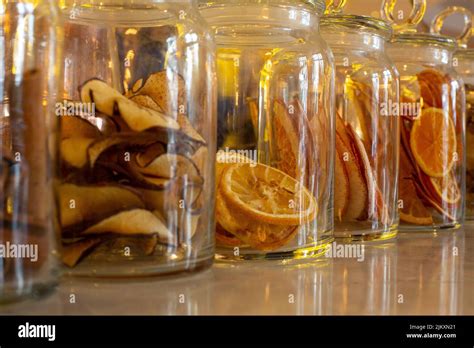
[0,223,474,315]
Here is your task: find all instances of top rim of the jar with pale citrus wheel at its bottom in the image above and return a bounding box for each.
[198,0,326,15]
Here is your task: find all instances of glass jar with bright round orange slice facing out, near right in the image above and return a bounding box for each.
[385,0,465,234]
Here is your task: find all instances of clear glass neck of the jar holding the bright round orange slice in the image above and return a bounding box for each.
[387,42,453,66]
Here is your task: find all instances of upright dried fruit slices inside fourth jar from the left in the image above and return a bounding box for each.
[334,75,398,240]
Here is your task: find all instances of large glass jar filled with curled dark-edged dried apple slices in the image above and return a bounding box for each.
[57,0,216,277]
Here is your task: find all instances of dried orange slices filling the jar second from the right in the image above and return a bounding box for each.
[400,68,465,227]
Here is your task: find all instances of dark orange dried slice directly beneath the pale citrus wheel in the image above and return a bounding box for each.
[216,190,298,251]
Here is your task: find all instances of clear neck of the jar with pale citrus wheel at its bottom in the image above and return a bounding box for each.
[201,3,319,34]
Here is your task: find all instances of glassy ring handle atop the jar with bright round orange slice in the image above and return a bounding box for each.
[380,0,426,33]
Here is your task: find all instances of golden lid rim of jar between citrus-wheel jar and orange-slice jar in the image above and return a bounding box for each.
[320,14,393,40]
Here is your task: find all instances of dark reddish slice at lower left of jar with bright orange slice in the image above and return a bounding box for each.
[399,147,433,225]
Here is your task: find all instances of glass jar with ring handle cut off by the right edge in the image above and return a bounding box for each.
[431,6,474,220]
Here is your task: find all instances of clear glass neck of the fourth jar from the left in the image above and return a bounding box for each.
[321,30,385,53]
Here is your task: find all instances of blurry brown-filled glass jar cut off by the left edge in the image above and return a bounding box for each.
[0,0,61,302]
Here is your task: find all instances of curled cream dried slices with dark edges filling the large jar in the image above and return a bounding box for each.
[57,75,209,267]
